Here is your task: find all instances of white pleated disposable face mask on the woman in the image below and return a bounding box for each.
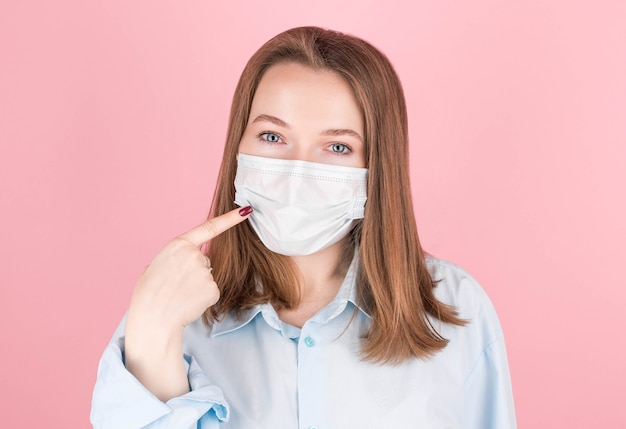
[235,153,367,256]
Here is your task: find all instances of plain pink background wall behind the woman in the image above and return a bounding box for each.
[0,0,626,429]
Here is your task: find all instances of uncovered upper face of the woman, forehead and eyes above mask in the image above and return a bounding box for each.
[239,63,366,167]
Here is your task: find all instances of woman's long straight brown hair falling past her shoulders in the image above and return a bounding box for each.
[204,27,464,362]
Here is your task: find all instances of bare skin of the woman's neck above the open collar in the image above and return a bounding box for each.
[278,238,350,327]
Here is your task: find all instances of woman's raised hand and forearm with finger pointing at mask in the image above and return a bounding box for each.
[125,207,252,402]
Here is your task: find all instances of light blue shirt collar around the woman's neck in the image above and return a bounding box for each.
[210,251,371,337]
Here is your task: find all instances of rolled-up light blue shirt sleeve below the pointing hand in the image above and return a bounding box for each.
[90,322,229,429]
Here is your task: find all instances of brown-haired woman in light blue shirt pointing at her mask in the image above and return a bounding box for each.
[91,27,515,429]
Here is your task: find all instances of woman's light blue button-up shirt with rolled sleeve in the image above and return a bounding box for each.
[91,258,516,429]
